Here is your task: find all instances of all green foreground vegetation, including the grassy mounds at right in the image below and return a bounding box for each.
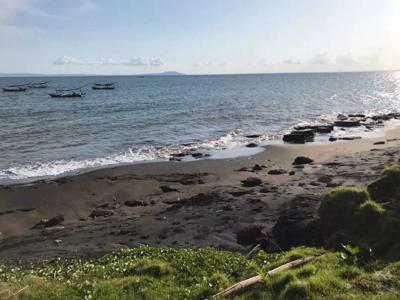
[0,167,400,300]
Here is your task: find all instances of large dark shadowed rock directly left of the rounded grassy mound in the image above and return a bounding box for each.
[272,195,321,250]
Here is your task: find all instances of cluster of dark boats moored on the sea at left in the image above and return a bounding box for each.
[2,81,115,98]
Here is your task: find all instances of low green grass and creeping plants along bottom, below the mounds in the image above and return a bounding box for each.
[0,247,400,299]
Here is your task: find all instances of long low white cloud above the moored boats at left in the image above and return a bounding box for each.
[53,55,165,67]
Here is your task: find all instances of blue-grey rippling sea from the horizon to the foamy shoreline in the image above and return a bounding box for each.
[0,72,400,182]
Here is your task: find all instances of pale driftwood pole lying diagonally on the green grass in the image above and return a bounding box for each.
[212,256,317,298]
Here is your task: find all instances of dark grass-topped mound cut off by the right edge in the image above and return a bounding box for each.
[368,165,400,202]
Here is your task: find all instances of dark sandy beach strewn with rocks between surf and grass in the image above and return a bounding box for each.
[0,123,400,260]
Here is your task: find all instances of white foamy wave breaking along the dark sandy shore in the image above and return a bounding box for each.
[0,110,396,180]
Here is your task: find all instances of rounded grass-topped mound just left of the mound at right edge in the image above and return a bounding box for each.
[318,188,369,236]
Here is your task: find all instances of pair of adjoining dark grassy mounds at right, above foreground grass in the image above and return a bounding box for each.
[319,166,400,260]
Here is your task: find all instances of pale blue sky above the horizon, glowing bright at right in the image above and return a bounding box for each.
[0,0,400,75]
